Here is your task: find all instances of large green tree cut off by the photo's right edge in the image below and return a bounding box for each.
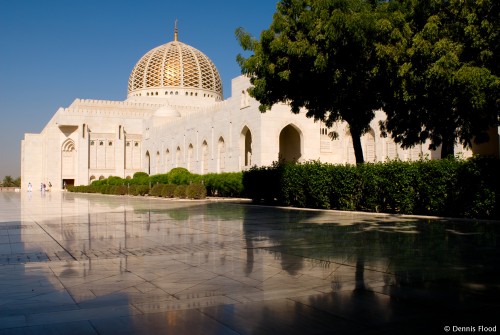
[382,0,500,158]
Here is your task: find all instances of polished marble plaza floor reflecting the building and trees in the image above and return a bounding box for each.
[0,192,500,335]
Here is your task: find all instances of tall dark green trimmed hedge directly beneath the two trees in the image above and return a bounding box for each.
[243,158,500,218]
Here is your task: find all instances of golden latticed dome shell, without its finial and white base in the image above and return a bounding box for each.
[128,41,222,97]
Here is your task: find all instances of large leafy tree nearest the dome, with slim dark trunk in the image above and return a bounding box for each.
[236,0,390,164]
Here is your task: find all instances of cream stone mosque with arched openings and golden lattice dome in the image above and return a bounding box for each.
[21,29,498,190]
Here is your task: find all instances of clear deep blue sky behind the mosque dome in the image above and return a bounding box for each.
[0,0,277,179]
